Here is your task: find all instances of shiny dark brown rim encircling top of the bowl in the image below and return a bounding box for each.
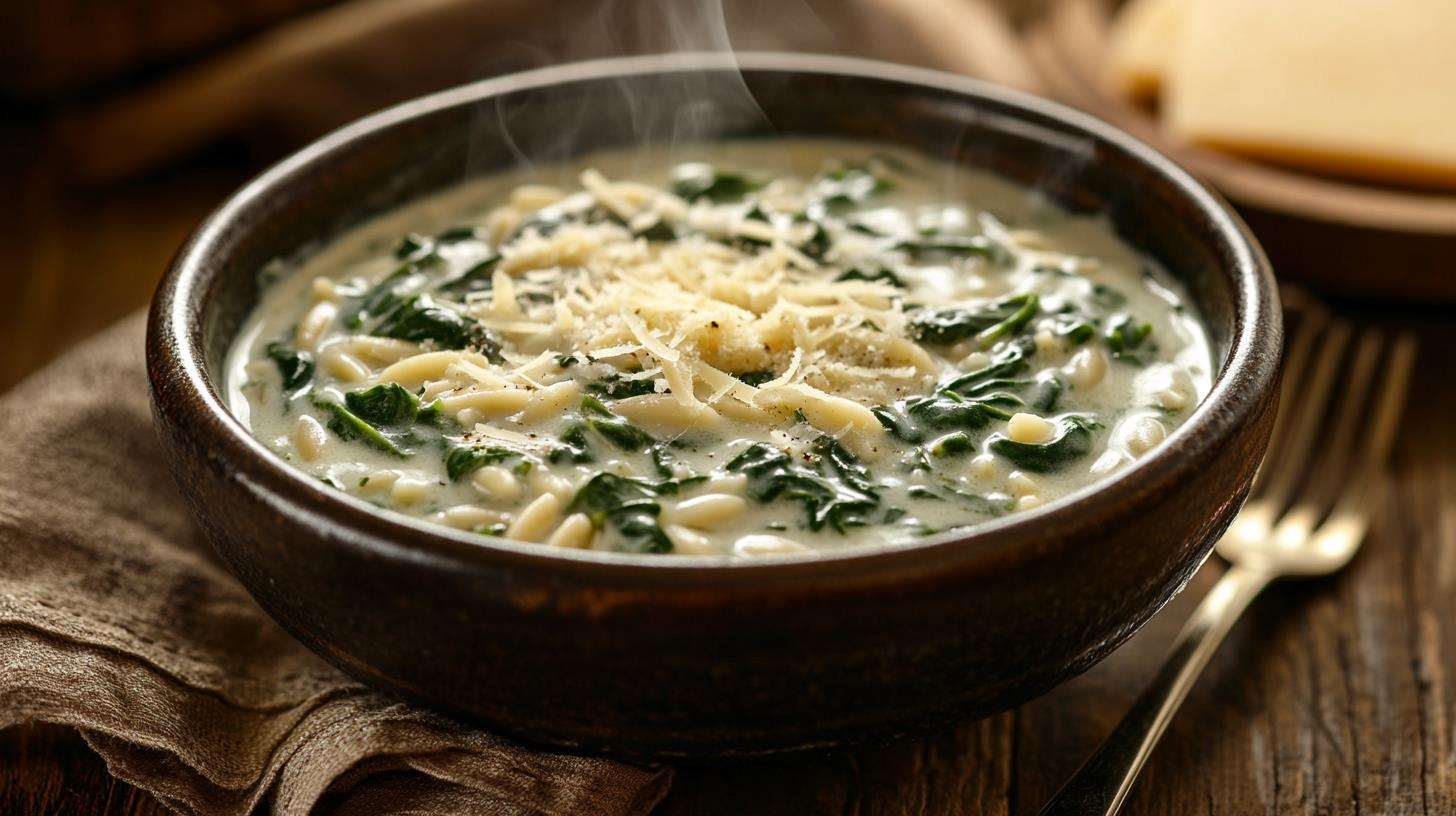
[147,52,1280,589]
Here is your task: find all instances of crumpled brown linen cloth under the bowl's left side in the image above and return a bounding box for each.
[0,315,671,816]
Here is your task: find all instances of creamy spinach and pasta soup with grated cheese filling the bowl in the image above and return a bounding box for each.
[229,140,1211,557]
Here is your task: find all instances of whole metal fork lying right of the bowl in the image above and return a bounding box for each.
[1038,307,1415,816]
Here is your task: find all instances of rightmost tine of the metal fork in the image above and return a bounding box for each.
[1313,334,1417,552]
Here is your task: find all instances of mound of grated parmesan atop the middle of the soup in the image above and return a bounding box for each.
[448,209,939,407]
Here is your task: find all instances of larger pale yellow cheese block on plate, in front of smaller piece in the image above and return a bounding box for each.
[1163,0,1456,185]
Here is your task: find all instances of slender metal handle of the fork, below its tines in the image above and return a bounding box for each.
[1038,565,1273,816]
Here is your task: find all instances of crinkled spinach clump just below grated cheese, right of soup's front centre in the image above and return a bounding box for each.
[727,436,879,533]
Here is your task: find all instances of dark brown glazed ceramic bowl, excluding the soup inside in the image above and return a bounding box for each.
[149,55,1280,756]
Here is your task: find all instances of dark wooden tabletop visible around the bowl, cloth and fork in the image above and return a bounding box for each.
[0,143,1456,816]
